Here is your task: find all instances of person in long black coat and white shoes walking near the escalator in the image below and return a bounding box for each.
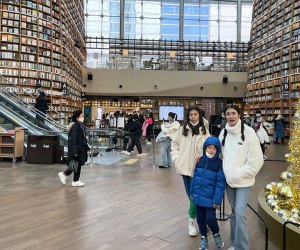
[58,110,89,187]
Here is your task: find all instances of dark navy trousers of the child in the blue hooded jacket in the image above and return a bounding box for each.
[196,205,219,237]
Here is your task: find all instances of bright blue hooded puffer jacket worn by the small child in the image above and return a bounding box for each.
[190,137,227,207]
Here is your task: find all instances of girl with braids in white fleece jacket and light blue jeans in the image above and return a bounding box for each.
[219,105,264,250]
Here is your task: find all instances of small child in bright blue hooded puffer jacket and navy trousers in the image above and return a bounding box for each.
[191,137,227,250]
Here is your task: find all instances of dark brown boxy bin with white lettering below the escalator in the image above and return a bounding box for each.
[27,135,59,164]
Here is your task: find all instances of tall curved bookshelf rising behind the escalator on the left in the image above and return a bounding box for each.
[0,0,86,123]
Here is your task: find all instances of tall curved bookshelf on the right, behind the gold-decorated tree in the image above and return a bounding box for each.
[245,0,300,129]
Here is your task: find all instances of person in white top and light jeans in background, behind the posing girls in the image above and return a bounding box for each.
[159,112,180,168]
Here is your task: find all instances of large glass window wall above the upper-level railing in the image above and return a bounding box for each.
[85,0,252,42]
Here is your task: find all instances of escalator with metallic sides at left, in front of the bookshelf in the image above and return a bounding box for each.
[0,76,68,151]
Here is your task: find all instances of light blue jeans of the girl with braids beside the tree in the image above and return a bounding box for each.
[226,186,250,250]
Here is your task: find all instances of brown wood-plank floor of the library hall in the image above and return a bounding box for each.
[0,142,287,250]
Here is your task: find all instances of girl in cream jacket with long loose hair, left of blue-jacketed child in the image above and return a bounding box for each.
[171,107,209,236]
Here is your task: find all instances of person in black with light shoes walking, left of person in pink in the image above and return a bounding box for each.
[124,114,143,156]
